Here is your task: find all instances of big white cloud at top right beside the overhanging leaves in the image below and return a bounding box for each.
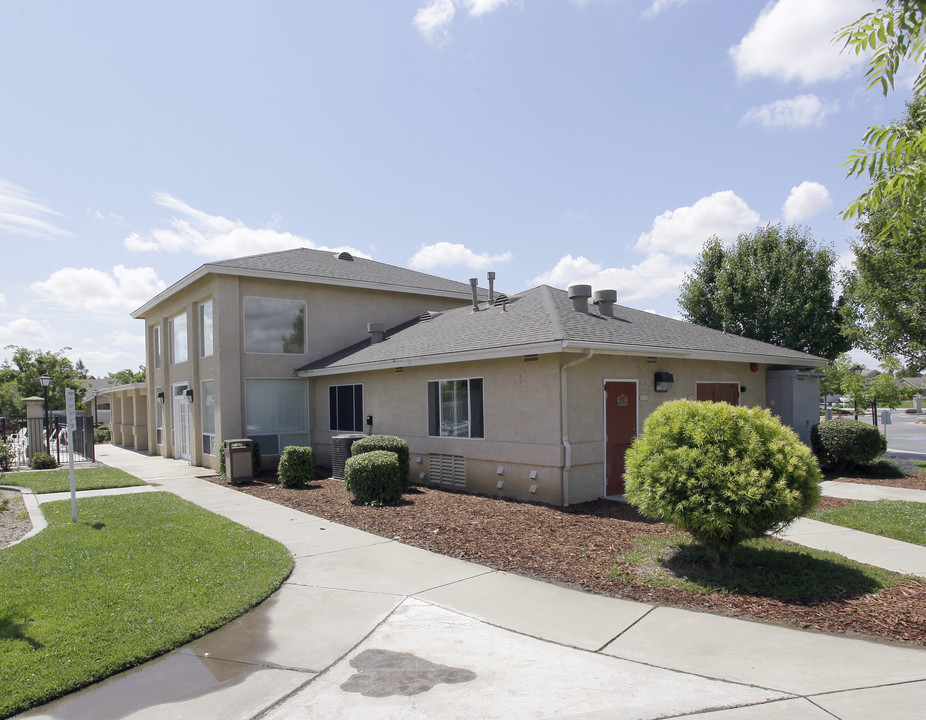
[730,0,875,84]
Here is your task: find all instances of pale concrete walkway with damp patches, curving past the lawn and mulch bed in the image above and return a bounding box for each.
[12,446,926,720]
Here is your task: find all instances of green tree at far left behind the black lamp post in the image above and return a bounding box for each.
[0,345,83,418]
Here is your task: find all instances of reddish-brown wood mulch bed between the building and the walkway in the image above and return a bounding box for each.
[211,476,926,646]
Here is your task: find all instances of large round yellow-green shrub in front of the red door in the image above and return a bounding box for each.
[625,400,820,560]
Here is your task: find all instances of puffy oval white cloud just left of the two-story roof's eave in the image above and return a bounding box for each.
[30,265,167,314]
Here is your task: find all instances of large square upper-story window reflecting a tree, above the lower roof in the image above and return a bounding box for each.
[244,297,305,355]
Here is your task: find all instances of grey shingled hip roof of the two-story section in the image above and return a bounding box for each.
[132,248,486,318]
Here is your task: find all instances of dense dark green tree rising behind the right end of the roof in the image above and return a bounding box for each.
[678,225,850,360]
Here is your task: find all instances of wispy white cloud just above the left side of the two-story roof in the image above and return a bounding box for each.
[123,192,369,258]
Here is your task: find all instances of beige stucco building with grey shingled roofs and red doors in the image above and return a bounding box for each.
[133,249,825,505]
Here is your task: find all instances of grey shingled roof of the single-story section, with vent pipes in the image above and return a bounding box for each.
[296,285,827,376]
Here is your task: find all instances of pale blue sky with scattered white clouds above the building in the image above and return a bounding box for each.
[0,0,909,375]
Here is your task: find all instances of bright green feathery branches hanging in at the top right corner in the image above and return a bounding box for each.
[837,0,926,240]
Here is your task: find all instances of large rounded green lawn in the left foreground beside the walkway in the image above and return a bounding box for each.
[0,492,293,718]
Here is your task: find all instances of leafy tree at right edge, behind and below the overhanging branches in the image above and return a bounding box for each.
[844,97,926,370]
